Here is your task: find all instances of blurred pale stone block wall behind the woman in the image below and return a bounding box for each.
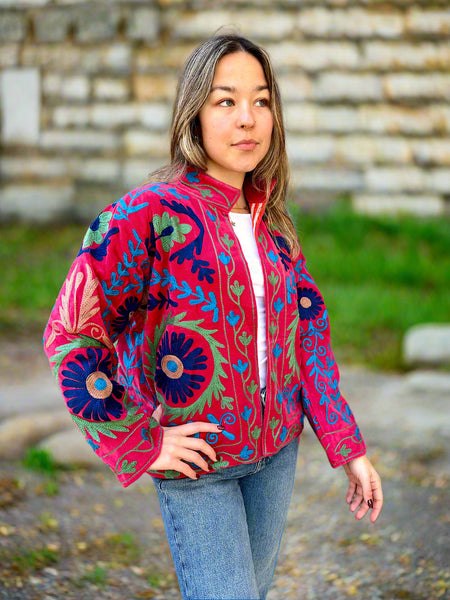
[0,0,450,221]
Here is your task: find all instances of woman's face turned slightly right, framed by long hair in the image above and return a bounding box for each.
[199,52,273,188]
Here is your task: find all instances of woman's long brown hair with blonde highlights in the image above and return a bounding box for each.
[147,33,299,257]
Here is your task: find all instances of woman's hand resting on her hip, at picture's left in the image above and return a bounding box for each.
[150,421,222,479]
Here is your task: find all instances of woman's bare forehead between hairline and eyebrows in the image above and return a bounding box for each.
[213,52,267,87]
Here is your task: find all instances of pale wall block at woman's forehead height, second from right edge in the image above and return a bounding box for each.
[313,72,383,102]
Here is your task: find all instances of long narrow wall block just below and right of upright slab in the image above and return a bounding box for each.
[39,129,119,152]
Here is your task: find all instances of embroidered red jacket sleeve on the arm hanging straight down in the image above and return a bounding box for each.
[295,246,366,467]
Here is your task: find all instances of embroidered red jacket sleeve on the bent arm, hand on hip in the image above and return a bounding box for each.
[44,194,162,487]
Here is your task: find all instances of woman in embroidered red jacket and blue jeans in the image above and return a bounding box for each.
[45,34,382,599]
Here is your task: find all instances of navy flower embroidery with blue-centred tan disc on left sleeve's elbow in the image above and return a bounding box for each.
[62,348,123,421]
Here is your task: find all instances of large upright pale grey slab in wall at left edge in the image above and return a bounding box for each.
[0,69,41,145]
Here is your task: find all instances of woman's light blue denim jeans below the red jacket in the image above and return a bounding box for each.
[153,438,298,600]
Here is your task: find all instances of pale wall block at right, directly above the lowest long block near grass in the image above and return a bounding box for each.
[364,167,425,192]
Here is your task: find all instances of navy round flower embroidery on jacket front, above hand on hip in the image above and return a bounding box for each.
[155,332,207,404]
